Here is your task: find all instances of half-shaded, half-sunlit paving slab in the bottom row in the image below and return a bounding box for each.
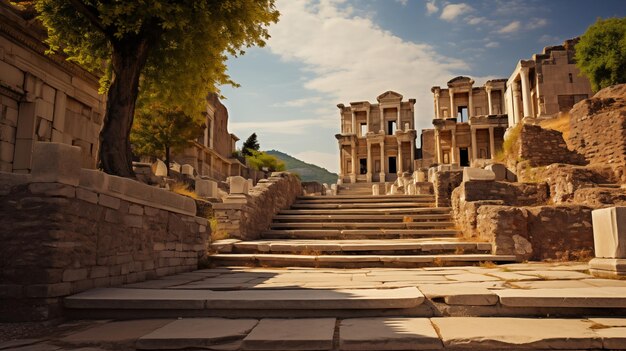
[339,318,443,351]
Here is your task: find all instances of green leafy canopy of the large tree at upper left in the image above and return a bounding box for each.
[35,0,279,115]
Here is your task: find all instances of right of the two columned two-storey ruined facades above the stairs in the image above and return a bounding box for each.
[421,76,508,167]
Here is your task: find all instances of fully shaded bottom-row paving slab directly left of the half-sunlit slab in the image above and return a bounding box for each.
[242,318,336,350]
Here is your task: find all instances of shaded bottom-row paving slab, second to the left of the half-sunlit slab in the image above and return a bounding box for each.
[136,318,258,350]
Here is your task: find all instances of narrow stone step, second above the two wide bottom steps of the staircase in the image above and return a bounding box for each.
[270,221,454,229]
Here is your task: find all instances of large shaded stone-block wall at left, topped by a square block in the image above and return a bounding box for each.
[0,143,209,320]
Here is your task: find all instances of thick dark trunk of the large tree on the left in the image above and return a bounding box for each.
[100,31,150,178]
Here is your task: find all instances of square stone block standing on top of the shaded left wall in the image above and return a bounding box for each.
[31,142,81,186]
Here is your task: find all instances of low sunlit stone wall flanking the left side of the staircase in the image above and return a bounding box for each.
[213,172,303,240]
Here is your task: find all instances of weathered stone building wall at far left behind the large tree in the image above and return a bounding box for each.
[0,1,106,173]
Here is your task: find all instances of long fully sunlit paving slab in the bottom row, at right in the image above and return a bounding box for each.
[431,317,602,350]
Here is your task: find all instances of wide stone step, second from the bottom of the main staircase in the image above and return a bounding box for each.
[217,239,491,254]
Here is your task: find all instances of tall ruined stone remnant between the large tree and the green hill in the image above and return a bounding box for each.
[173,93,247,180]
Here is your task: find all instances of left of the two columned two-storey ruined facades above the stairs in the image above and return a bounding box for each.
[335,91,416,183]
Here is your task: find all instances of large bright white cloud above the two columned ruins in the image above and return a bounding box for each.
[266,0,468,135]
